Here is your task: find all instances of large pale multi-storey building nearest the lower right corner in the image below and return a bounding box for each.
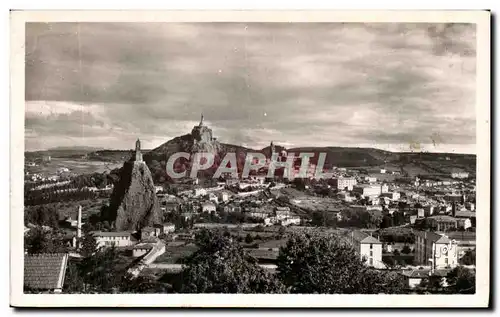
[415,231,458,270]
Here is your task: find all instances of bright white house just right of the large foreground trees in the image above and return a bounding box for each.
[351,231,385,269]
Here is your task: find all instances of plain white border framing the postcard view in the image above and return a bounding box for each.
[10,11,491,307]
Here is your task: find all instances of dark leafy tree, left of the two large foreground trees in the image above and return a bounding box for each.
[180,230,283,293]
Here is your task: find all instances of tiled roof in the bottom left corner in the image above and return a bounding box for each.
[24,253,68,290]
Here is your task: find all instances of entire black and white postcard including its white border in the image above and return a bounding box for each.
[11,11,490,307]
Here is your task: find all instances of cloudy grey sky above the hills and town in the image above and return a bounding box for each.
[25,23,476,153]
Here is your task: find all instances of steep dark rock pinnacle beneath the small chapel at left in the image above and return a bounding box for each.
[103,161,162,231]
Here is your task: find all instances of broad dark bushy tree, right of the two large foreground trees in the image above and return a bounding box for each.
[277,234,405,294]
